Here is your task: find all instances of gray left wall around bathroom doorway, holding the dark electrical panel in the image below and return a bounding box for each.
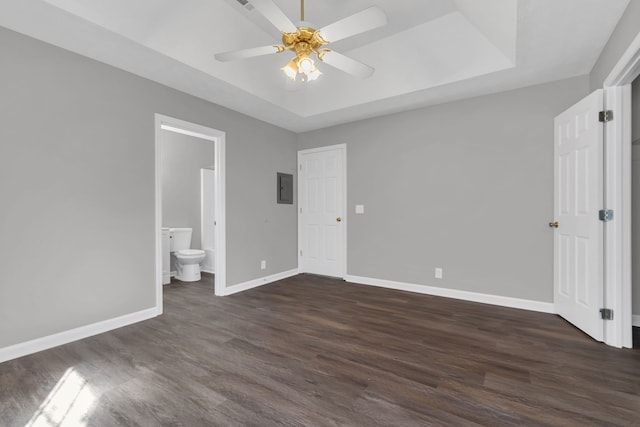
[0,28,297,347]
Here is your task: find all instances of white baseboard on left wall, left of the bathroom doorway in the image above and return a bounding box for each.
[0,307,158,363]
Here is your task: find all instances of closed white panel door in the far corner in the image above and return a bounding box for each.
[298,145,346,277]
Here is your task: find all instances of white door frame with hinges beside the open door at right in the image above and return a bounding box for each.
[604,34,640,348]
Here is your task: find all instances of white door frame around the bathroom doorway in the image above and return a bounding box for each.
[155,114,227,315]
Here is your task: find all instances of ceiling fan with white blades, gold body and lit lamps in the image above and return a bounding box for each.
[215,0,387,81]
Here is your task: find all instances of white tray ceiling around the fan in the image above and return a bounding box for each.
[0,0,629,132]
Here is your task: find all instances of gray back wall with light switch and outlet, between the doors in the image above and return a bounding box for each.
[299,76,589,302]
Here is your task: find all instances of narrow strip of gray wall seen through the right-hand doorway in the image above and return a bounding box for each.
[631,77,640,316]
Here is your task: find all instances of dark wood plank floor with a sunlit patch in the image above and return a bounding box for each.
[0,275,640,426]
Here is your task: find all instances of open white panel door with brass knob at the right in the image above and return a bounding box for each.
[553,90,604,341]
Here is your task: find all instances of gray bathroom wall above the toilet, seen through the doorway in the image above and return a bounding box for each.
[161,130,214,249]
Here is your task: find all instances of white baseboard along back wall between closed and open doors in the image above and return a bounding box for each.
[344,275,555,313]
